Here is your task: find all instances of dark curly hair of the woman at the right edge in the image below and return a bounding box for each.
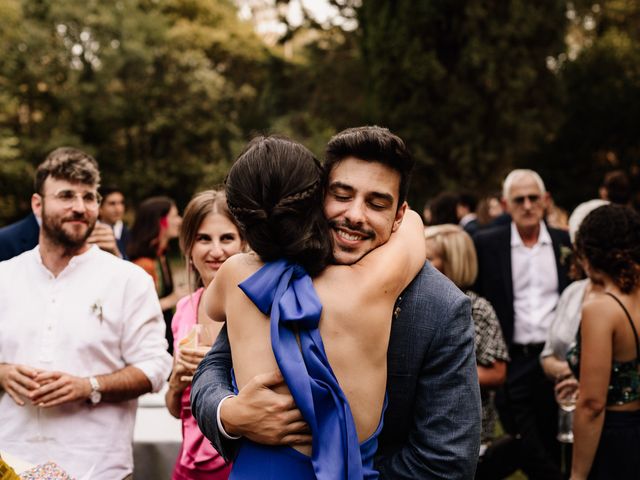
[576,204,640,293]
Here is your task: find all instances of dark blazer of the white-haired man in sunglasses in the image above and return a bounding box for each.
[473,223,571,345]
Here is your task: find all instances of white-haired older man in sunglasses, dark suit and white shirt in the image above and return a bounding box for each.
[474,170,570,480]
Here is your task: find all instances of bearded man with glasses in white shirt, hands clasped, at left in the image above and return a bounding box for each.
[0,148,171,480]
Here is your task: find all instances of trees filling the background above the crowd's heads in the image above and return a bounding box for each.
[0,0,640,225]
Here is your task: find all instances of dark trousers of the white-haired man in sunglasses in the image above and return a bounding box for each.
[496,344,563,480]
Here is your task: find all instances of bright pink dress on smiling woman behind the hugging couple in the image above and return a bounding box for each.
[171,288,231,480]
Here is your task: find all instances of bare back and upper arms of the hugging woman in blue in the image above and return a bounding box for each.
[206,212,425,453]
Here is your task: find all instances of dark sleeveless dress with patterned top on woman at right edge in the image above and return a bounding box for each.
[567,292,640,480]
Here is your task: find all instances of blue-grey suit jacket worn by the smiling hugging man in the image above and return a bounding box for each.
[191,262,481,480]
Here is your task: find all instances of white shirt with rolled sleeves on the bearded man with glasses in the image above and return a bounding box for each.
[0,246,171,480]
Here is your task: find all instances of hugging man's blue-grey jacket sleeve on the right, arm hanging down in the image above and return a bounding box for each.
[377,295,481,480]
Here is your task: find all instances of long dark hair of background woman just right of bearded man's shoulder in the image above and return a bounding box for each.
[127,197,175,261]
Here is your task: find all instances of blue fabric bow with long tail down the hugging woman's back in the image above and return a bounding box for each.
[239,259,363,480]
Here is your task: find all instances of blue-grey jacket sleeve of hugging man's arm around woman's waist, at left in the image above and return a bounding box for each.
[191,325,240,462]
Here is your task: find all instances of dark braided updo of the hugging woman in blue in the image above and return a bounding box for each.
[225,136,331,276]
